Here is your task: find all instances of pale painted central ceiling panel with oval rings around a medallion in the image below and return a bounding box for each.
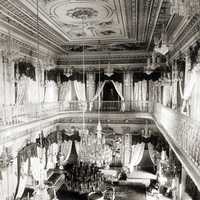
[43,0,127,41]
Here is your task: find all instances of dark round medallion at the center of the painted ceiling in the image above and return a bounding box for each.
[66,7,98,20]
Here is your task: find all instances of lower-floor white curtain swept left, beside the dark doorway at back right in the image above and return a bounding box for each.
[129,142,145,172]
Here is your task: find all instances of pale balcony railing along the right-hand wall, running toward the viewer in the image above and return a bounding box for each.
[153,103,200,188]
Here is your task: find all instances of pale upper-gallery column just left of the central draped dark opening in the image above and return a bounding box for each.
[86,72,95,101]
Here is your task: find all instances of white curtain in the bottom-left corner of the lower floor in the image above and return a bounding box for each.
[0,158,17,200]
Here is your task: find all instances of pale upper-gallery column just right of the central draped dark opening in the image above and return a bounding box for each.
[123,71,133,111]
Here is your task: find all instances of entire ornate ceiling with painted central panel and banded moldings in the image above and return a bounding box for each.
[0,0,175,68]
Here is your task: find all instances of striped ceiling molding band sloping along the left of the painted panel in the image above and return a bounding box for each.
[0,0,66,52]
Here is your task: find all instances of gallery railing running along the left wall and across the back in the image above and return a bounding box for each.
[0,101,153,127]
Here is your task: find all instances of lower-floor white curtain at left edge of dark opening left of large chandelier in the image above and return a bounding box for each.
[61,140,72,165]
